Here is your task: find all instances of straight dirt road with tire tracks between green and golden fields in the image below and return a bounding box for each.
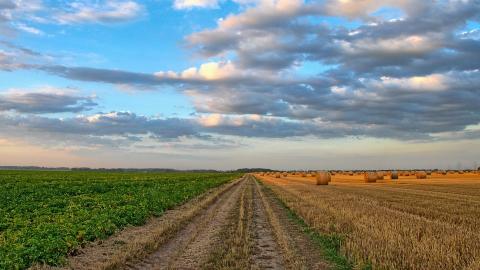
[62,175,329,270]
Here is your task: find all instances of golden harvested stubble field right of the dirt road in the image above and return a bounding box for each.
[256,173,480,270]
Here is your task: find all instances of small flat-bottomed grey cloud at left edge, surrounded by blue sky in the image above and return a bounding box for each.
[0,87,97,114]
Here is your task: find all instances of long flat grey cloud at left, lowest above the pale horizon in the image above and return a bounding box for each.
[0,112,198,146]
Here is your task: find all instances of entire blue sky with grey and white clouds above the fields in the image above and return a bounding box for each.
[0,0,480,169]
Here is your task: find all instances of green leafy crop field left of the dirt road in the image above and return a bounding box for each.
[0,171,239,269]
